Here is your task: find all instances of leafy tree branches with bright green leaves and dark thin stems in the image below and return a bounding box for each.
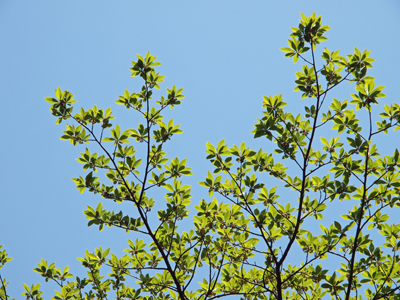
[0,13,400,300]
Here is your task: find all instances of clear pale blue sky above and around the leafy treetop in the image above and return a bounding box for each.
[0,0,400,299]
